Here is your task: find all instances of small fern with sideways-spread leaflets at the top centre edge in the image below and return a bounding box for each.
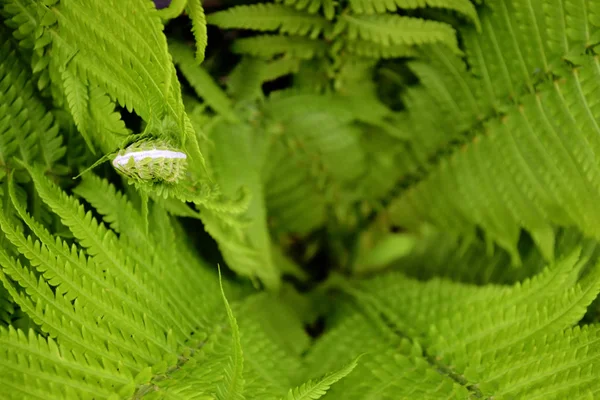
[207,0,468,92]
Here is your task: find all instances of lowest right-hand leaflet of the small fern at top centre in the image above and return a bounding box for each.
[335,15,460,53]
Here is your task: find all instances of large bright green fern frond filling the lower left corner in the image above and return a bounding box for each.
[0,167,260,398]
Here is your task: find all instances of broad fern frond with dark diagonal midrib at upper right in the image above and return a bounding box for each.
[392,2,600,263]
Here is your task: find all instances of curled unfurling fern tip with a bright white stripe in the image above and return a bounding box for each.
[112,140,187,183]
